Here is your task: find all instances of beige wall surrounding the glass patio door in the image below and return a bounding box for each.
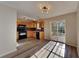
[45,12,77,46]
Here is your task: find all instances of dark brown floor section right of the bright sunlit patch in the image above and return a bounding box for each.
[65,45,78,58]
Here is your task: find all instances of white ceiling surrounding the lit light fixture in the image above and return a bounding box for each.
[0,1,78,19]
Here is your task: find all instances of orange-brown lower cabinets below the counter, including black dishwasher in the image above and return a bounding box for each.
[16,31,44,41]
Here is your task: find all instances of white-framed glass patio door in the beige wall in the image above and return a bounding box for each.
[50,20,66,43]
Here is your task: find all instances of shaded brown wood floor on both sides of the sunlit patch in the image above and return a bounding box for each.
[3,40,78,58]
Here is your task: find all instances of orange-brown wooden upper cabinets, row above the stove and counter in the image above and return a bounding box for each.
[17,19,44,30]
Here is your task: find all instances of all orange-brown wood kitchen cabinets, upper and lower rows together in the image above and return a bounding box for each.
[17,19,44,40]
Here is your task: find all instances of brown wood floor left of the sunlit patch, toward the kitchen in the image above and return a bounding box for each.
[2,39,48,58]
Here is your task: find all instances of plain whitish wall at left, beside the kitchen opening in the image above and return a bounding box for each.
[0,5,17,57]
